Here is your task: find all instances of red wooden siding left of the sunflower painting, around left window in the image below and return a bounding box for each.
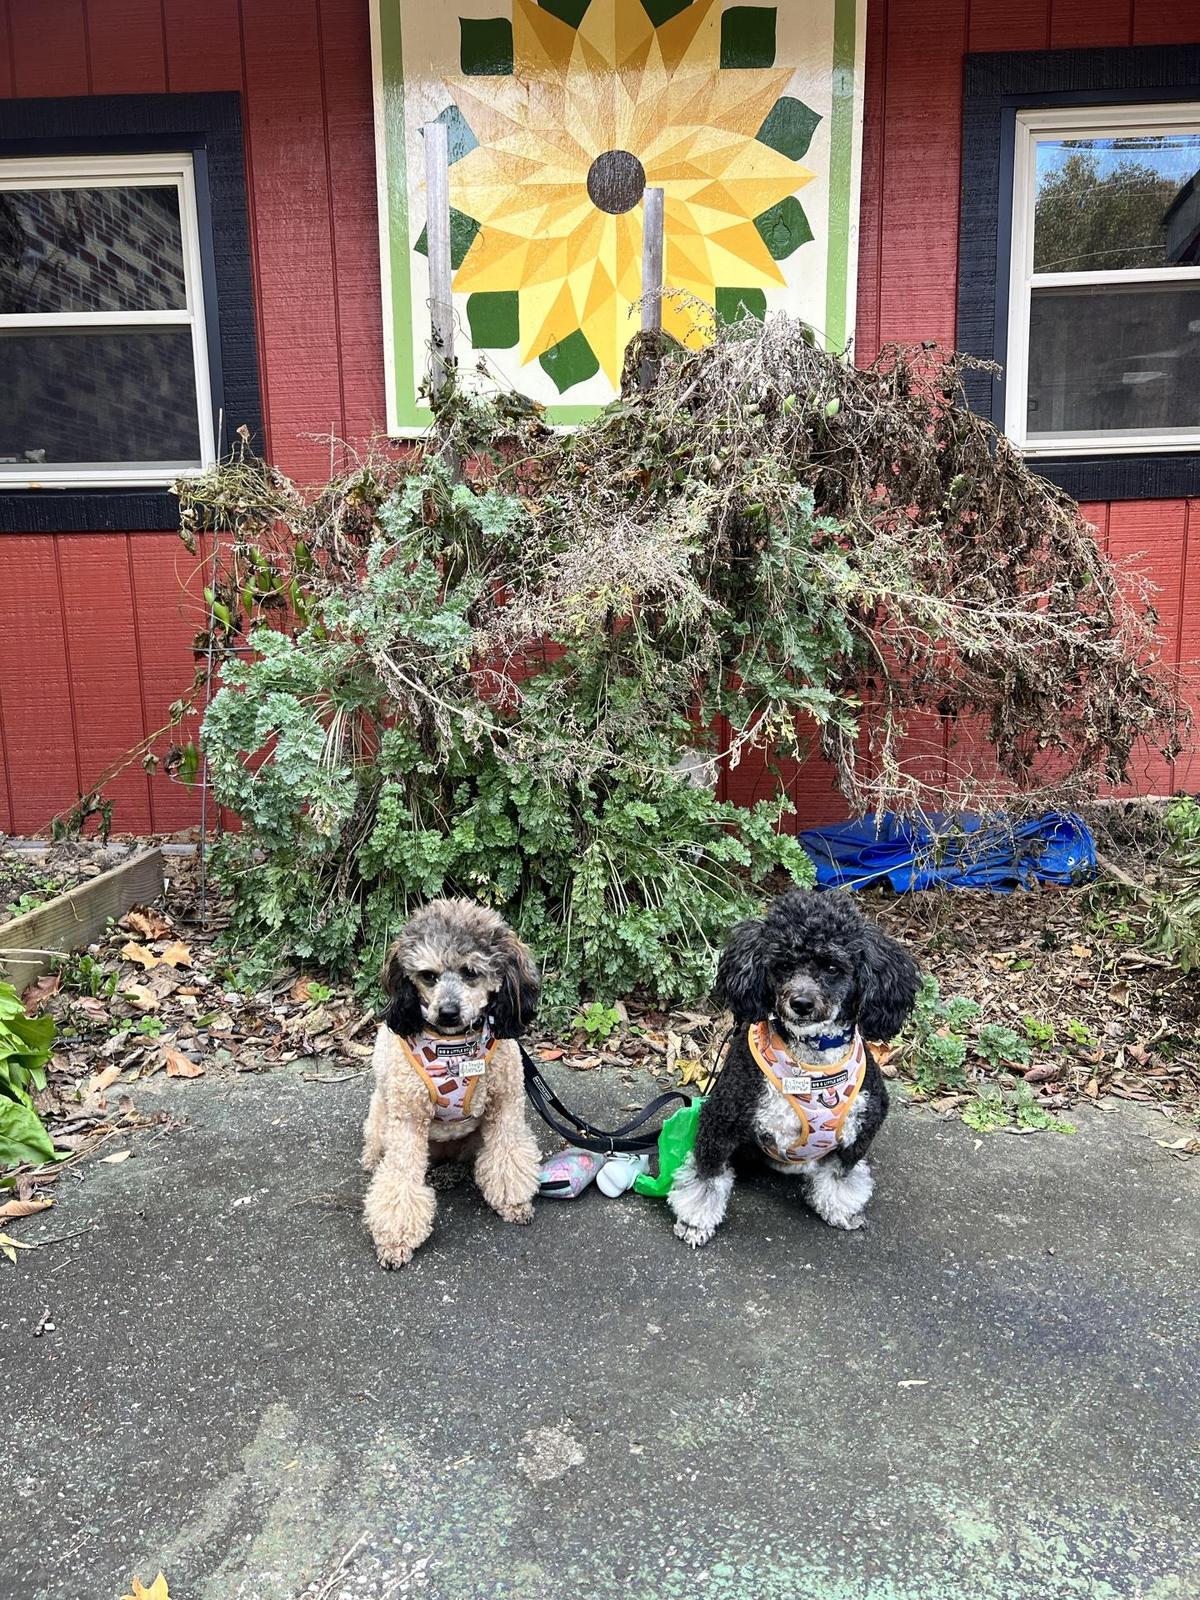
[0,0,384,832]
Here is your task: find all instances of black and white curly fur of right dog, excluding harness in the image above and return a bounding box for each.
[667,890,918,1248]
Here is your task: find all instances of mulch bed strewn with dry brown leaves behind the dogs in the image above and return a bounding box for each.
[0,853,1200,1195]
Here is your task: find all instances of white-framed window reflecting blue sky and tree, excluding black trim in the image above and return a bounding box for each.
[1005,104,1200,456]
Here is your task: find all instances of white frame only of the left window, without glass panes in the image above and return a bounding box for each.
[0,154,216,490]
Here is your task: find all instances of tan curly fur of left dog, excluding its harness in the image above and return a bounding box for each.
[362,899,541,1267]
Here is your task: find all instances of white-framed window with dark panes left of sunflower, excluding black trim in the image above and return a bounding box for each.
[0,154,216,490]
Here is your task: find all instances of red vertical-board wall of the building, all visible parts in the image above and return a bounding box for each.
[0,0,1200,832]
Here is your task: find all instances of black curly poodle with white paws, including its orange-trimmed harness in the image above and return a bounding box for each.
[667,890,918,1248]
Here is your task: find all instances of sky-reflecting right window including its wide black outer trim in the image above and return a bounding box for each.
[958,46,1200,499]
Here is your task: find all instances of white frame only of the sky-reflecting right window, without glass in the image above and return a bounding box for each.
[1005,104,1200,458]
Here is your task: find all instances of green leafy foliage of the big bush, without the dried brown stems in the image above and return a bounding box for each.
[203,466,835,1013]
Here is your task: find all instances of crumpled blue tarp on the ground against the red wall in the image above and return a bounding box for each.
[800,811,1096,894]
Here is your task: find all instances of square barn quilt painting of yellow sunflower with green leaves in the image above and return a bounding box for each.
[373,0,866,434]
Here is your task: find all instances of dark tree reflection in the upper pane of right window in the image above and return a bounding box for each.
[1034,150,1179,272]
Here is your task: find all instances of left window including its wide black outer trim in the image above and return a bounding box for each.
[0,94,261,531]
